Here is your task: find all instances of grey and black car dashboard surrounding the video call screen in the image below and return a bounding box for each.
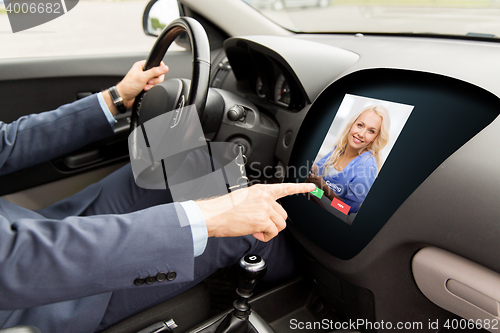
[206,34,500,331]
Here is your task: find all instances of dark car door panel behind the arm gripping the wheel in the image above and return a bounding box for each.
[0,51,195,204]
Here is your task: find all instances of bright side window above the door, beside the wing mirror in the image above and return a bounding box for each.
[0,0,184,59]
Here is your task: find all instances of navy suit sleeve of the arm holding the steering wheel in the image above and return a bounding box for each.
[0,94,113,175]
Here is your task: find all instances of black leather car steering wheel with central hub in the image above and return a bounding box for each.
[129,17,216,189]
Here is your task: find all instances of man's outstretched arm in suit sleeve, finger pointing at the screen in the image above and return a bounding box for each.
[0,184,314,310]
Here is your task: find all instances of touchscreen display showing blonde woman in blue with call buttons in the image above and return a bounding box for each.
[306,94,413,224]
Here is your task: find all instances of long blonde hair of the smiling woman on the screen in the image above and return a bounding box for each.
[323,105,391,174]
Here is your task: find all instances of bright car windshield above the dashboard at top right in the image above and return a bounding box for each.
[240,0,500,38]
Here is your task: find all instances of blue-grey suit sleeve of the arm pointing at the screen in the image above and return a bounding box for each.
[0,199,194,310]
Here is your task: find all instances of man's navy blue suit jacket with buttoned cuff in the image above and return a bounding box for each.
[0,95,194,332]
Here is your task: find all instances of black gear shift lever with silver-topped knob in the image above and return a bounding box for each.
[216,254,267,333]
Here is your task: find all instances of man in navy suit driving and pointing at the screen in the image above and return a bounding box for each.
[0,62,315,332]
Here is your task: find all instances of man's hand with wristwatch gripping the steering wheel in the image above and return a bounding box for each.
[102,60,168,115]
